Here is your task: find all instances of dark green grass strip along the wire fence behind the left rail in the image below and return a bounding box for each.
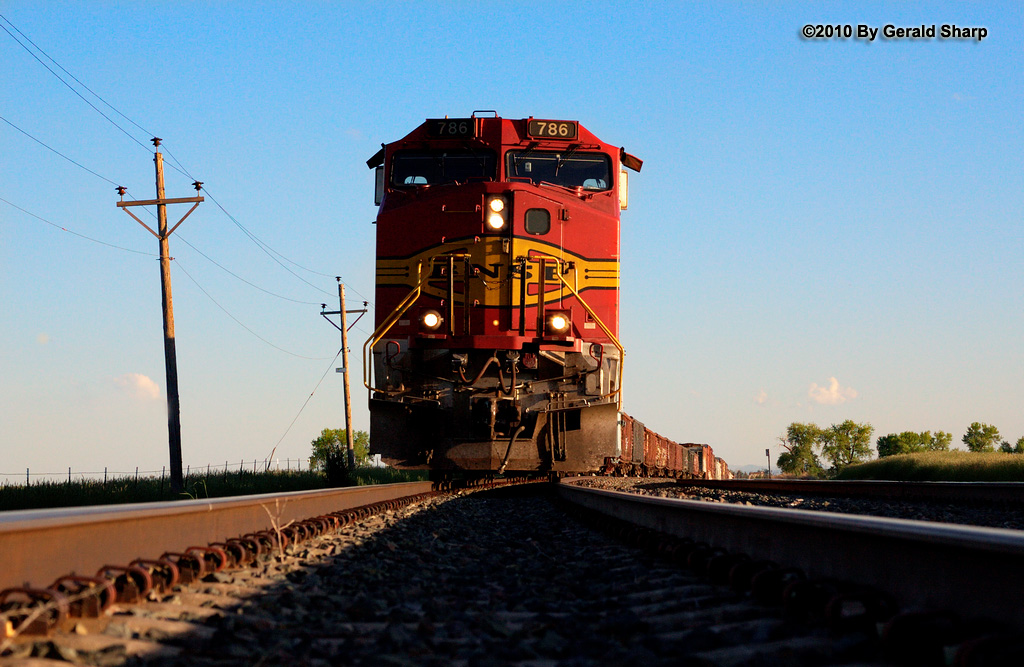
[0,468,426,511]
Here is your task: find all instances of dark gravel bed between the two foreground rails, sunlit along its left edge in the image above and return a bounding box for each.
[0,489,871,667]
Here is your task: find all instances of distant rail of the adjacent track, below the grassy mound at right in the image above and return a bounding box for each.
[679,480,1024,503]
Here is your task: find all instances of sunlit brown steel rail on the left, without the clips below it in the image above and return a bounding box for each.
[0,482,431,589]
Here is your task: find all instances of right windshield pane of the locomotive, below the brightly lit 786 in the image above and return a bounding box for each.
[507,147,611,190]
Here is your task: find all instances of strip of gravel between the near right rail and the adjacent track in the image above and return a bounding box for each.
[573,477,1024,531]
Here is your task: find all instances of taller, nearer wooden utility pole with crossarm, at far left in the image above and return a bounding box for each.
[117,137,204,493]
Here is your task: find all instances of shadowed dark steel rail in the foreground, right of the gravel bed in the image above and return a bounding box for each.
[557,481,1024,629]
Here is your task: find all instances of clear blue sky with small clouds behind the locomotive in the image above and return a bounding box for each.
[0,1,1024,475]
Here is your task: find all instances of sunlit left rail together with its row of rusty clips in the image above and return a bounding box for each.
[0,483,431,655]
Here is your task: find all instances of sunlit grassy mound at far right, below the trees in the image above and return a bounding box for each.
[837,452,1024,482]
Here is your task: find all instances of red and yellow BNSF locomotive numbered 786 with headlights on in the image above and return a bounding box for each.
[364,114,641,472]
